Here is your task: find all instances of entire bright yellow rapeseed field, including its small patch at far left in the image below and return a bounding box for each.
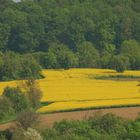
[0,69,140,112]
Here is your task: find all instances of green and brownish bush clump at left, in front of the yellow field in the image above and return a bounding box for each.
[0,79,42,123]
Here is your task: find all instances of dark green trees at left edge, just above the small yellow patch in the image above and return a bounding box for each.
[0,52,41,81]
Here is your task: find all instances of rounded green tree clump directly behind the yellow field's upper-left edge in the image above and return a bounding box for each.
[33,48,78,69]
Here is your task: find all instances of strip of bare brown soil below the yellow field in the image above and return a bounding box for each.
[0,107,140,130]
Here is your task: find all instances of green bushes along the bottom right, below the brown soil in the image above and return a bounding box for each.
[42,114,130,140]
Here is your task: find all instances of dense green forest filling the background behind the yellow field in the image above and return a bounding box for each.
[0,0,140,80]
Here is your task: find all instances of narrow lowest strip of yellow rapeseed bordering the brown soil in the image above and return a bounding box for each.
[38,99,140,113]
